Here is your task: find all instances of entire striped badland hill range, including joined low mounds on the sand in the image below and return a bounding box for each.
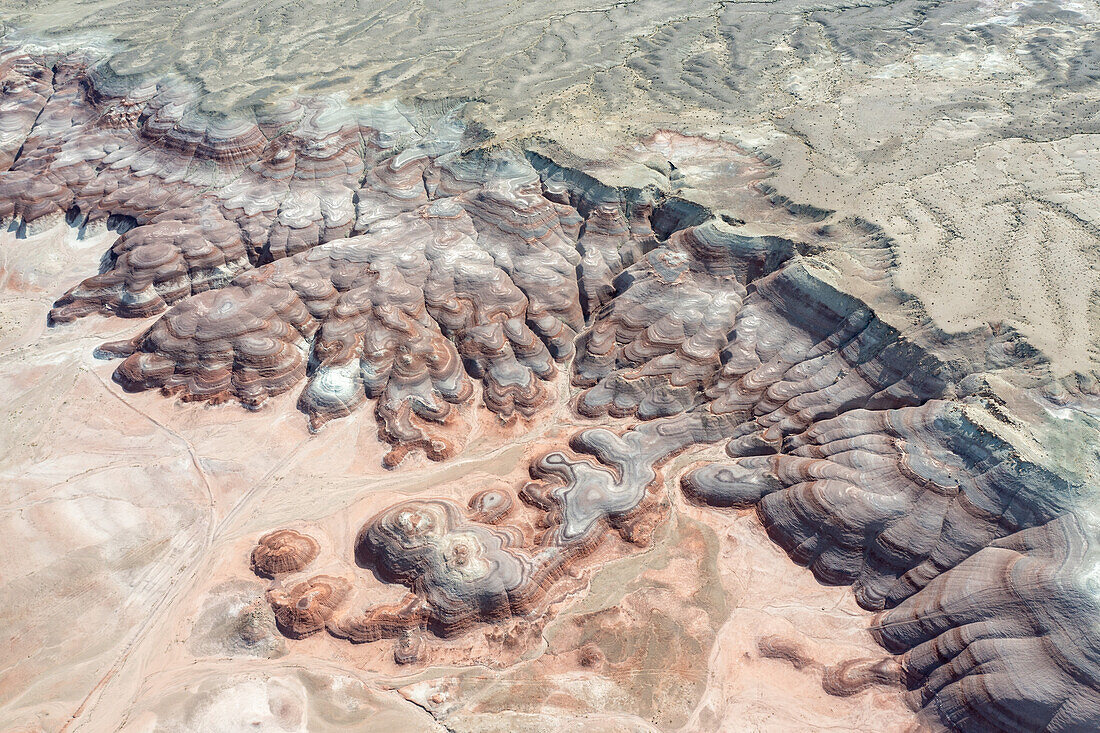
[0,51,1100,731]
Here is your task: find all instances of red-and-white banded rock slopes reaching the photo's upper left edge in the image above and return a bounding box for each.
[0,52,433,314]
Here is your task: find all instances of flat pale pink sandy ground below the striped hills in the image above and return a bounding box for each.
[0,226,912,731]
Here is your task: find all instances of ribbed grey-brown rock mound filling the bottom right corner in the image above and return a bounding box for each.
[872,514,1100,731]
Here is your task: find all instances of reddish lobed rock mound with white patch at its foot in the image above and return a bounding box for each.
[94,193,580,462]
